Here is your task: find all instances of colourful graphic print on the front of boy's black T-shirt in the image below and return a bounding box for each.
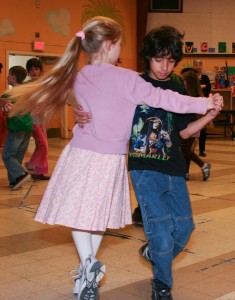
[129,105,173,160]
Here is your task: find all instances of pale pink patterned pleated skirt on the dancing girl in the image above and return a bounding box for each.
[35,145,132,231]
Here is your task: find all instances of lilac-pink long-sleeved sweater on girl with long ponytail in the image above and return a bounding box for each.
[70,64,208,154]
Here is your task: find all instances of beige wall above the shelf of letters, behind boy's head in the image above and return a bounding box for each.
[147,0,235,53]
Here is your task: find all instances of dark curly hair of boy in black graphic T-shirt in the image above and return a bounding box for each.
[139,25,184,72]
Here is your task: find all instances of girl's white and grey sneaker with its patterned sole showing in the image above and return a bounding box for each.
[78,255,106,300]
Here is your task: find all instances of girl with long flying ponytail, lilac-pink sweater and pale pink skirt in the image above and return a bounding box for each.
[8,17,223,300]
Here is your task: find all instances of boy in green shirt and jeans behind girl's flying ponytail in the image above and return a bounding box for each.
[0,66,33,190]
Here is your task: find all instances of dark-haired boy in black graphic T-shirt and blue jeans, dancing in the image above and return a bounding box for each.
[128,26,220,300]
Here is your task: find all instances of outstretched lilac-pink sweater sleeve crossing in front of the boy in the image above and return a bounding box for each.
[122,70,208,115]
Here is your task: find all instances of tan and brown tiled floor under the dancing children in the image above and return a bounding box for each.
[0,137,235,300]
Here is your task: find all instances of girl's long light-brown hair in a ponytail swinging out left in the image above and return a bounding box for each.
[7,16,122,121]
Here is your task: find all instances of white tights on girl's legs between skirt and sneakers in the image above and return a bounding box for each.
[72,229,104,266]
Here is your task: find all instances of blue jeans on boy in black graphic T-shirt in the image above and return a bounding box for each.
[130,170,194,288]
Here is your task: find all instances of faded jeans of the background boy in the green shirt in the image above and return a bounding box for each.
[2,130,32,183]
